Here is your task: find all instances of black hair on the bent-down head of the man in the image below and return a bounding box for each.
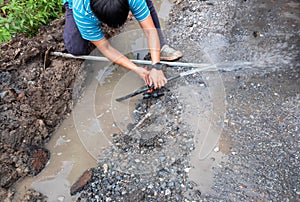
[90,0,129,28]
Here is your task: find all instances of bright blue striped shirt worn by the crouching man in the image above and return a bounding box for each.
[63,0,150,41]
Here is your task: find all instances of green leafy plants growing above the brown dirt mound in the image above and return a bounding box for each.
[0,0,62,43]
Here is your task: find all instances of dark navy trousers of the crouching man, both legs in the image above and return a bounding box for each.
[63,0,166,55]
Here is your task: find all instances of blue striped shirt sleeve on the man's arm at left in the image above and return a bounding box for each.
[73,7,104,41]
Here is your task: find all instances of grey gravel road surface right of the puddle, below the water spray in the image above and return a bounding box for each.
[206,68,300,201]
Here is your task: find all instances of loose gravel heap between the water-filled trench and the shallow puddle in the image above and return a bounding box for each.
[78,84,194,201]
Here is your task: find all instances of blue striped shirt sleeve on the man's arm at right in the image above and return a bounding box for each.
[128,0,150,22]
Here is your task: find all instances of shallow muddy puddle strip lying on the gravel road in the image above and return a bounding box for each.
[178,71,231,197]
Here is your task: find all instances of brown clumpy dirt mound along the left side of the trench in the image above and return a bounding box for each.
[0,18,83,201]
